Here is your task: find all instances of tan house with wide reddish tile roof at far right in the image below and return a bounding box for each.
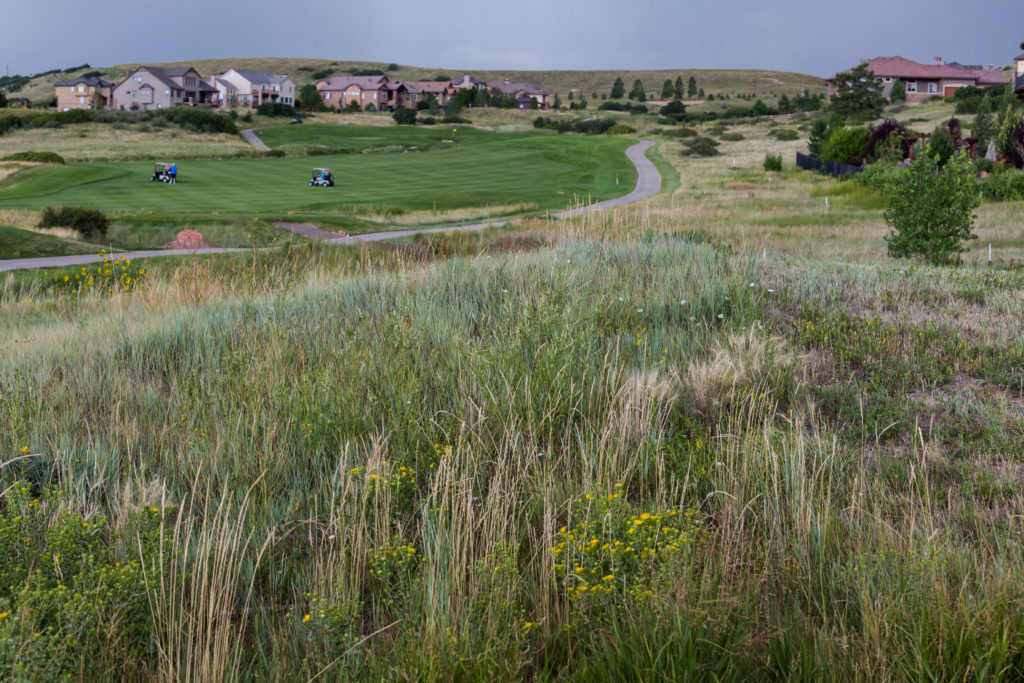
[828,57,1008,102]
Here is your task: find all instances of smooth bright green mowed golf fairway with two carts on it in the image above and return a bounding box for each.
[0,126,636,216]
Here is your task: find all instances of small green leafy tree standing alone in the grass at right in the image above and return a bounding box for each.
[885,148,981,263]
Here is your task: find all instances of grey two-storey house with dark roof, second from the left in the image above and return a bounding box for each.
[110,67,219,112]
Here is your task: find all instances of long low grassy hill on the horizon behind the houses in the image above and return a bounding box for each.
[4,57,825,101]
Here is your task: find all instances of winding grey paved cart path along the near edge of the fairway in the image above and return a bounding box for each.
[0,139,662,271]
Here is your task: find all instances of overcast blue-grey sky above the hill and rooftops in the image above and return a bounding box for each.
[0,0,1024,76]
